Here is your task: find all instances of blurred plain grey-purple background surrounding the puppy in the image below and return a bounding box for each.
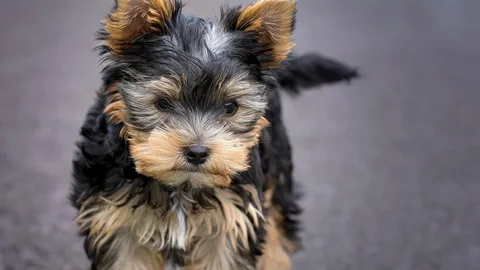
[0,0,480,270]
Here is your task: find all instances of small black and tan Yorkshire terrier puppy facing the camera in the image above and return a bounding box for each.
[70,0,358,270]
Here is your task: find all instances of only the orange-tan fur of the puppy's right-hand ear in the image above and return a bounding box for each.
[237,0,296,67]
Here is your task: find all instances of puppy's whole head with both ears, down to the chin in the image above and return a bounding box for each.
[101,0,295,187]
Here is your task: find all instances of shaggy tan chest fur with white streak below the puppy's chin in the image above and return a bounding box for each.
[77,185,263,269]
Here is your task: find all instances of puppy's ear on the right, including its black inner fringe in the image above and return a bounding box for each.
[222,0,296,67]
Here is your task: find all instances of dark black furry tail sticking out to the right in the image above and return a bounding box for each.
[275,53,360,94]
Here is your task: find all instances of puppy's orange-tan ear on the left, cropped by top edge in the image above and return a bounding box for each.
[102,0,182,52]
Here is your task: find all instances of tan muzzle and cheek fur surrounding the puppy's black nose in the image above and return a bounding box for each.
[127,117,268,187]
